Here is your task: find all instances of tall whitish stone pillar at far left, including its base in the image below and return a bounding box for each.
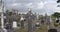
[0,0,6,32]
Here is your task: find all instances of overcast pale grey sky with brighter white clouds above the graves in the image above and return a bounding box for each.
[4,0,60,15]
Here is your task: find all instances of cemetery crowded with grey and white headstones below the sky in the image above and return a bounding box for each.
[0,0,60,32]
